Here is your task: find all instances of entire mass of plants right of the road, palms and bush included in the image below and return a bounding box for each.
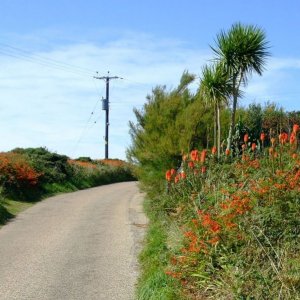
[127,23,300,300]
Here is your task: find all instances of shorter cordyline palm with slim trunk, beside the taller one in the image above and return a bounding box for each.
[200,64,232,157]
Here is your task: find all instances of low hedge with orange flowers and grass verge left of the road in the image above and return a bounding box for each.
[0,148,134,225]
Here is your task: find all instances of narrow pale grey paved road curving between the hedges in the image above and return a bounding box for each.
[0,182,146,300]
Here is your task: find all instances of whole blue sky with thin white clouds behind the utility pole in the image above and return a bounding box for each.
[0,0,300,158]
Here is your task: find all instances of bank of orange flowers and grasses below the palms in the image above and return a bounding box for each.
[140,126,300,299]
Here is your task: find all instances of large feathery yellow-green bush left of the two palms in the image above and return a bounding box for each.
[127,72,212,190]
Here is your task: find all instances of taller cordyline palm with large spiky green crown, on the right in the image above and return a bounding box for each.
[211,23,270,149]
